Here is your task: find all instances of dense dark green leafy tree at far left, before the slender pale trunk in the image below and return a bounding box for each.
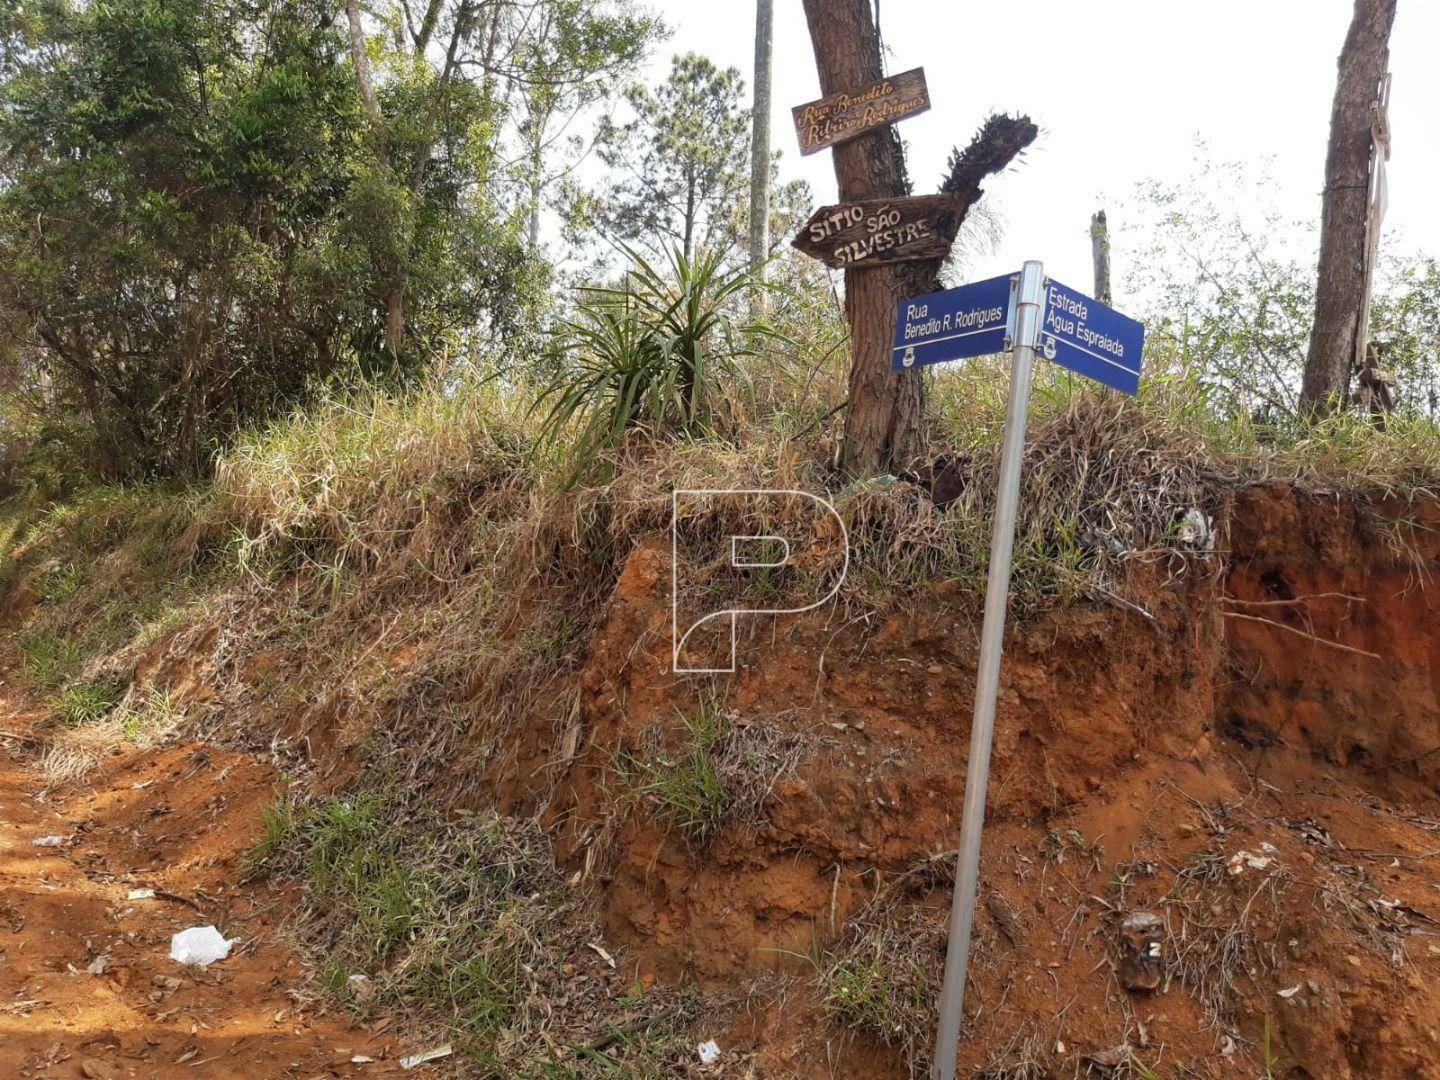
[0,0,371,478]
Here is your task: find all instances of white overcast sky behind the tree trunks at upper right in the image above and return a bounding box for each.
[648,0,1440,291]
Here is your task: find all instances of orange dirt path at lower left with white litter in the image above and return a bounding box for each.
[0,717,399,1080]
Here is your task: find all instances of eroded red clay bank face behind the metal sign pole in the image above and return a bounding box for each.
[538,488,1440,1080]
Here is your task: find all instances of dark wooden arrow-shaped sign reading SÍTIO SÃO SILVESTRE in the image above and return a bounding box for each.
[792,194,960,269]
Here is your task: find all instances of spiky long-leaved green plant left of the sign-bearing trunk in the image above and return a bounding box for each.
[536,248,760,481]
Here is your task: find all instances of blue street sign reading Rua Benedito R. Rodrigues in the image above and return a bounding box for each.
[890,274,1015,372]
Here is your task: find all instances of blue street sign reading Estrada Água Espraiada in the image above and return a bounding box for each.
[1035,278,1145,393]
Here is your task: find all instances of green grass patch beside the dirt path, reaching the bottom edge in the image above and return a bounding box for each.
[248,789,717,1080]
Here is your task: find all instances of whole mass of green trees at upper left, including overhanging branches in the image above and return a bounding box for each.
[0,0,596,486]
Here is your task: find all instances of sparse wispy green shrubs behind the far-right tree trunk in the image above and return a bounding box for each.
[1119,152,1440,423]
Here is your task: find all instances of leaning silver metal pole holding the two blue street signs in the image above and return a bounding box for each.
[935,262,1044,1080]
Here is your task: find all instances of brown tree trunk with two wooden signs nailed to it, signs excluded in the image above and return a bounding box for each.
[805,0,924,477]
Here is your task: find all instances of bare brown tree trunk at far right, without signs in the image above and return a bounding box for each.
[1300,0,1395,413]
